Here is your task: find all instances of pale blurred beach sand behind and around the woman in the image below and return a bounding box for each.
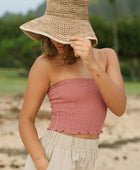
[0,94,140,170]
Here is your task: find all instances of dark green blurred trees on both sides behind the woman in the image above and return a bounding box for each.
[0,9,140,80]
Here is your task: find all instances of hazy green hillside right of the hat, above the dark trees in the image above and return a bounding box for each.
[89,0,140,22]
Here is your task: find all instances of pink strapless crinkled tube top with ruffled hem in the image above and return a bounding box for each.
[47,78,107,135]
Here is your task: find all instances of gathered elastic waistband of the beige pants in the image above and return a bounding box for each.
[45,129,99,152]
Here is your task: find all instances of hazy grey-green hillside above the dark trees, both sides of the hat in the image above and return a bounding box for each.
[30,0,140,21]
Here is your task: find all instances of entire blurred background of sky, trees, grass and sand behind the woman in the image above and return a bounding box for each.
[0,0,140,170]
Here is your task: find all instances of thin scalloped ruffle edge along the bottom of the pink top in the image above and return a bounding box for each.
[47,127,103,135]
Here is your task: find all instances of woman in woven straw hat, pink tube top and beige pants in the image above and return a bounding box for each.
[19,0,126,170]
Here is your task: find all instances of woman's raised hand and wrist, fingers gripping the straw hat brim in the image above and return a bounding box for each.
[68,36,97,70]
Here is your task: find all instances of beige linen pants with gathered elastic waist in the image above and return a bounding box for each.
[24,129,99,170]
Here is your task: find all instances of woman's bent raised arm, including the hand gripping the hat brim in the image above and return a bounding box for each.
[69,36,127,116]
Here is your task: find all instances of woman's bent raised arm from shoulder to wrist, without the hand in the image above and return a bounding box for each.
[90,48,127,116]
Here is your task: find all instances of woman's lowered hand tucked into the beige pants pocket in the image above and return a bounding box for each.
[34,157,49,170]
